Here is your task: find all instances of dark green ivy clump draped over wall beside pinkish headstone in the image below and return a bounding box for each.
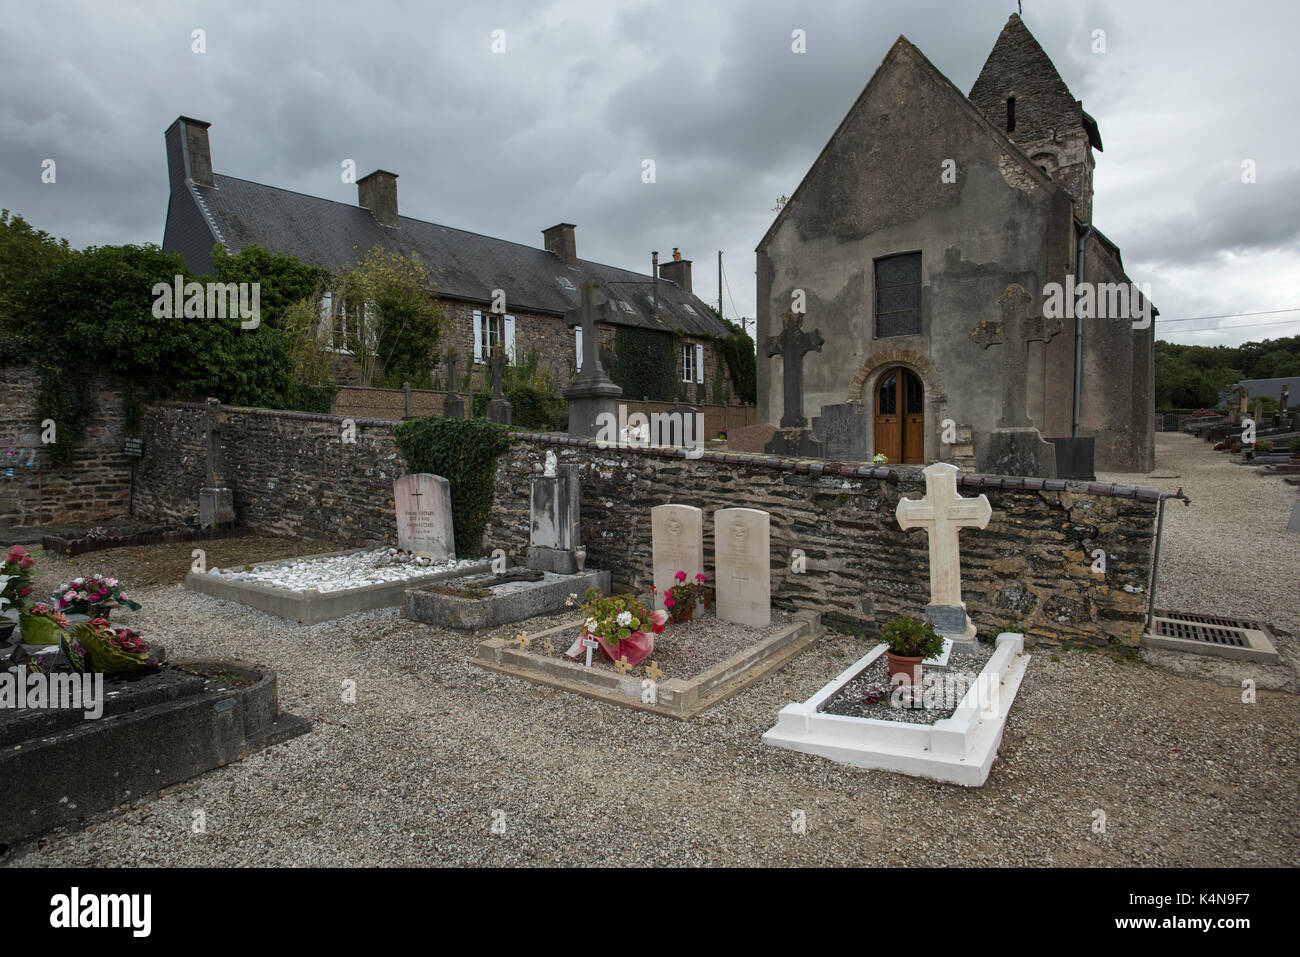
[393,416,510,558]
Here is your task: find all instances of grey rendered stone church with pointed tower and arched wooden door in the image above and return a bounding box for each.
[757,14,1154,472]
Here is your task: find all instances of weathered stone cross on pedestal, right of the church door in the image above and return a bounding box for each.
[970,282,1062,479]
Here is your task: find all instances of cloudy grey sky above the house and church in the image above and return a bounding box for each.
[0,0,1300,345]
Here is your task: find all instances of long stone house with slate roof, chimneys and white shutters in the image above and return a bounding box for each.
[163,116,735,400]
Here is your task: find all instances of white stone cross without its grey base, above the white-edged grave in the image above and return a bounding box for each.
[894,462,993,605]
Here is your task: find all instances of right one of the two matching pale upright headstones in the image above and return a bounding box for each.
[714,508,772,628]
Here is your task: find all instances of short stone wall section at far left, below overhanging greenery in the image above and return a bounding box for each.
[0,365,131,528]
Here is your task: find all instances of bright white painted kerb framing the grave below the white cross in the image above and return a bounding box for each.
[763,632,1031,788]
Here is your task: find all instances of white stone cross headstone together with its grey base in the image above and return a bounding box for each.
[894,462,993,651]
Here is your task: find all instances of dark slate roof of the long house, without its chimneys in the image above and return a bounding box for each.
[187,174,731,335]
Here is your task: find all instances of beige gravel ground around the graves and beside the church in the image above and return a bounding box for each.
[5,436,1300,867]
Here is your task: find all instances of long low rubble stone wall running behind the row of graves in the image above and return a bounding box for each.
[137,403,1160,646]
